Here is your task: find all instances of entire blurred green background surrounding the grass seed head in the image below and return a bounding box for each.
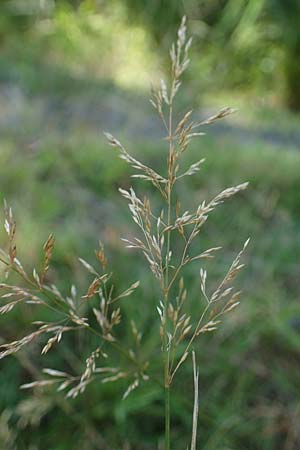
[0,0,300,450]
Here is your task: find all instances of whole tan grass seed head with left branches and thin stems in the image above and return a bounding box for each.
[0,17,249,450]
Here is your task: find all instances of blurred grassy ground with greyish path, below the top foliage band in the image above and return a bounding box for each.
[0,4,300,450]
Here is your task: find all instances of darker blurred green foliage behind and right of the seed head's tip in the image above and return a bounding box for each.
[122,0,300,110]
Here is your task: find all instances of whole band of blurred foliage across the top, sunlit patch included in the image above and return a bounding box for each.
[0,0,300,110]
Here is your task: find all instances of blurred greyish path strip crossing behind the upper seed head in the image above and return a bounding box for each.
[0,84,300,148]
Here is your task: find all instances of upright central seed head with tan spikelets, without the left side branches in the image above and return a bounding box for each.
[106,17,248,408]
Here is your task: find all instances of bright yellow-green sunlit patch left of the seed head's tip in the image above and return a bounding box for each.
[37,5,158,90]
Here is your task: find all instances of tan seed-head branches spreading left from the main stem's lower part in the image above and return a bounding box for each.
[0,202,149,397]
